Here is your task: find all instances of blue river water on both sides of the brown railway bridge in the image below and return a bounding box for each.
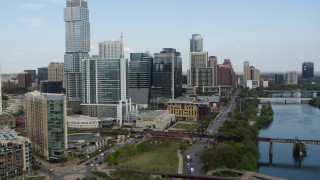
[259,104,320,180]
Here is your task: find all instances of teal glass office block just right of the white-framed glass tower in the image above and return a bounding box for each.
[128,52,153,106]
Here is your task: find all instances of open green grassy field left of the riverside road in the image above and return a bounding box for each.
[118,138,188,173]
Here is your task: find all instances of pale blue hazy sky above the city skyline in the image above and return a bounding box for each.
[0,0,320,73]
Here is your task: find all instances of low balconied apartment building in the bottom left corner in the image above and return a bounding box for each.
[0,126,32,179]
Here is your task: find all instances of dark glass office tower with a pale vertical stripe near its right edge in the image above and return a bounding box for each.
[150,48,182,100]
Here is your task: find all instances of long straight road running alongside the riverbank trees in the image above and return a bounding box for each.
[186,89,240,175]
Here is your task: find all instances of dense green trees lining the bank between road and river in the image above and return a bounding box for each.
[201,90,273,172]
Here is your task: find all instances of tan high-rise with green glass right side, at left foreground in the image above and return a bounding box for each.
[25,91,67,160]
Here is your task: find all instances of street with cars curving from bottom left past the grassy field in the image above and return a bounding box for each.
[41,138,138,180]
